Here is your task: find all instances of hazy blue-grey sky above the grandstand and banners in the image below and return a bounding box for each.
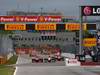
[0,0,100,16]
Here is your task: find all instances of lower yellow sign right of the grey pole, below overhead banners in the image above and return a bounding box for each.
[83,38,96,47]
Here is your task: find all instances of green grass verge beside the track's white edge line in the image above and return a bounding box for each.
[0,56,17,75]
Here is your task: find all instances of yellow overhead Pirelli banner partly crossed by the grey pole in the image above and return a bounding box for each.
[65,23,86,31]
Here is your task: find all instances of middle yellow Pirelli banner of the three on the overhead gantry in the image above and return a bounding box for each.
[35,23,56,30]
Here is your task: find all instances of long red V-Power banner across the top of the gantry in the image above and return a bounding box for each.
[0,16,61,22]
